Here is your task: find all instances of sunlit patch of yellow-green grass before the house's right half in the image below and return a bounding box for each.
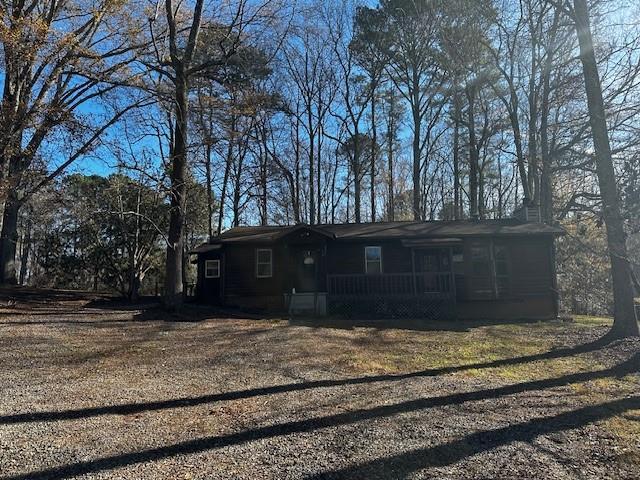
[345,319,606,382]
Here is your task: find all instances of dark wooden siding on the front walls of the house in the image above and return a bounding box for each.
[198,232,557,318]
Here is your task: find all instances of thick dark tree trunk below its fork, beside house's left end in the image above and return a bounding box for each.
[165,71,189,309]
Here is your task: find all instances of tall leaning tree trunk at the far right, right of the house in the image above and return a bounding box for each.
[573,0,640,337]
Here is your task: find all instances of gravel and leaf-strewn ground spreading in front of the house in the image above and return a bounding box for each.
[0,292,640,479]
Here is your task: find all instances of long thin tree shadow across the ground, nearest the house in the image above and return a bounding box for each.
[0,336,611,425]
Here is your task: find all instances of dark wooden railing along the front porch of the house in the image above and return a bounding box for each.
[327,272,455,298]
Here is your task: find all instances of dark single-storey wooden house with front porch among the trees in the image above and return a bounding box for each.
[191,219,563,319]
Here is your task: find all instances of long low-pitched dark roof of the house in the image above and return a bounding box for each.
[191,218,565,253]
